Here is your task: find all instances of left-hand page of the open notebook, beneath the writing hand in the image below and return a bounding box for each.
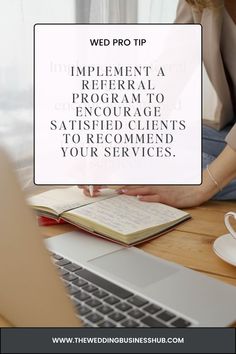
[28,186,115,214]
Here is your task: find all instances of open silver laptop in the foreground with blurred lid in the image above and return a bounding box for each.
[0,151,236,328]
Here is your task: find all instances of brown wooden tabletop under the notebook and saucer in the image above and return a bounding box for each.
[0,201,236,326]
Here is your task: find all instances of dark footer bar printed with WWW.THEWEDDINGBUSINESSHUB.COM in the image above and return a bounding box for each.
[1,328,235,354]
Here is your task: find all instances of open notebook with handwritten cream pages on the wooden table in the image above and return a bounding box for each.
[29,187,190,245]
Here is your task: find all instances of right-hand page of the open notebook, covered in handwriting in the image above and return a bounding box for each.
[70,195,188,235]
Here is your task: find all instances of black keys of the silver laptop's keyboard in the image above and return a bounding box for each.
[52,253,192,327]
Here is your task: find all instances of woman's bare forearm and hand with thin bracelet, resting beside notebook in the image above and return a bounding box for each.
[120,145,236,208]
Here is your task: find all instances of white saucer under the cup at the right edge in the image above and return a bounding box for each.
[213,234,236,266]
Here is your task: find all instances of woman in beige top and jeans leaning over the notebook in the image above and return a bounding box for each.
[84,0,236,208]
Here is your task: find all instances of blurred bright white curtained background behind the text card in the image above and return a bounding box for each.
[0,0,178,192]
